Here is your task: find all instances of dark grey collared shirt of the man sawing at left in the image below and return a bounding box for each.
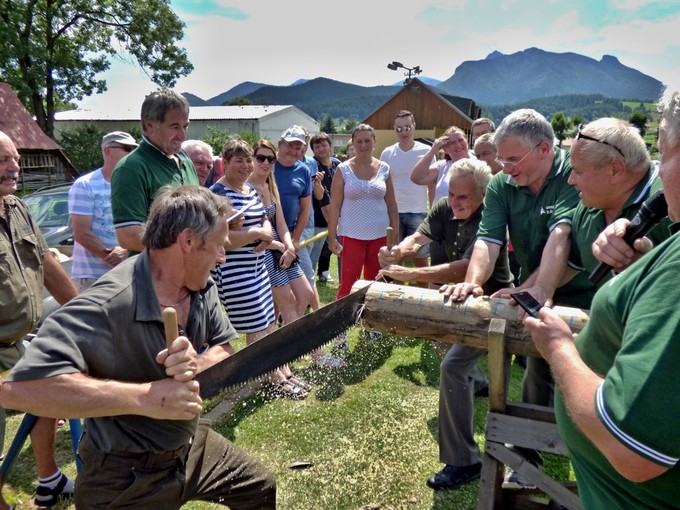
[9,251,238,453]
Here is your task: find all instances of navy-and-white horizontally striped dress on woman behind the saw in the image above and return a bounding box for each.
[210,182,274,333]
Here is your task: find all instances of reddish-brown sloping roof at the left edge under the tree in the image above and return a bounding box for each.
[0,83,61,151]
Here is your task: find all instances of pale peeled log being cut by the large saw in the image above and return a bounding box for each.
[352,280,588,356]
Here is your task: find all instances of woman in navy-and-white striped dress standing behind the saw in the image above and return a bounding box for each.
[210,139,308,398]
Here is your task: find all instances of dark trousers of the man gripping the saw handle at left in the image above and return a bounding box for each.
[75,420,276,510]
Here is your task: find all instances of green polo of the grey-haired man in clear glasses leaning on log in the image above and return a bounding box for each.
[477,148,592,308]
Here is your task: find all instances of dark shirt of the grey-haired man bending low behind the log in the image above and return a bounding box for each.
[417,198,512,295]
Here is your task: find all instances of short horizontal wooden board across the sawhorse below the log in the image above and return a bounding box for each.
[486,412,569,455]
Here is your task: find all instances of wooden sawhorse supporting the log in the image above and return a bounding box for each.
[477,318,583,510]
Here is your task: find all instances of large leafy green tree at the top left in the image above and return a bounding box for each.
[0,0,193,136]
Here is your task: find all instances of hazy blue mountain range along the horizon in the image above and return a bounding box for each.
[184,48,663,119]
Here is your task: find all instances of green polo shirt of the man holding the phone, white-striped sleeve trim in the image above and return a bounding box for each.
[555,224,680,509]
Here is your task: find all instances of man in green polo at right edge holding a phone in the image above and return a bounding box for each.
[525,90,680,509]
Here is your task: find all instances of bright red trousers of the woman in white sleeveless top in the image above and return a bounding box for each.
[335,236,387,299]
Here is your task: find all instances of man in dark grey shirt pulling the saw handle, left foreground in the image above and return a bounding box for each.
[0,186,276,510]
